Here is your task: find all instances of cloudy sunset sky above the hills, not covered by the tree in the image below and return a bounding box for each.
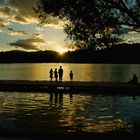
[0,0,140,51]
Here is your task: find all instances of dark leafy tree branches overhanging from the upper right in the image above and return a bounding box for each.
[34,0,140,48]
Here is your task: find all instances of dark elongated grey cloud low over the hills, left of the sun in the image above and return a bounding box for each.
[9,38,47,50]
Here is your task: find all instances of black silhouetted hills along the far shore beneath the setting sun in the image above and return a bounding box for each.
[0,43,140,63]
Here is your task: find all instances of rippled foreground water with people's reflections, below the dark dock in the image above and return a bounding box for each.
[0,92,140,133]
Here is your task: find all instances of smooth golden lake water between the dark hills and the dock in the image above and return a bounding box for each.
[0,63,140,82]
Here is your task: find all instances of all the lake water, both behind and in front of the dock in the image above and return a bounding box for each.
[0,63,140,133]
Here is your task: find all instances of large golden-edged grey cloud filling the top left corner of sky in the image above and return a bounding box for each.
[0,0,38,24]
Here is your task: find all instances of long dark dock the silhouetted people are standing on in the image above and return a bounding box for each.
[0,80,140,95]
